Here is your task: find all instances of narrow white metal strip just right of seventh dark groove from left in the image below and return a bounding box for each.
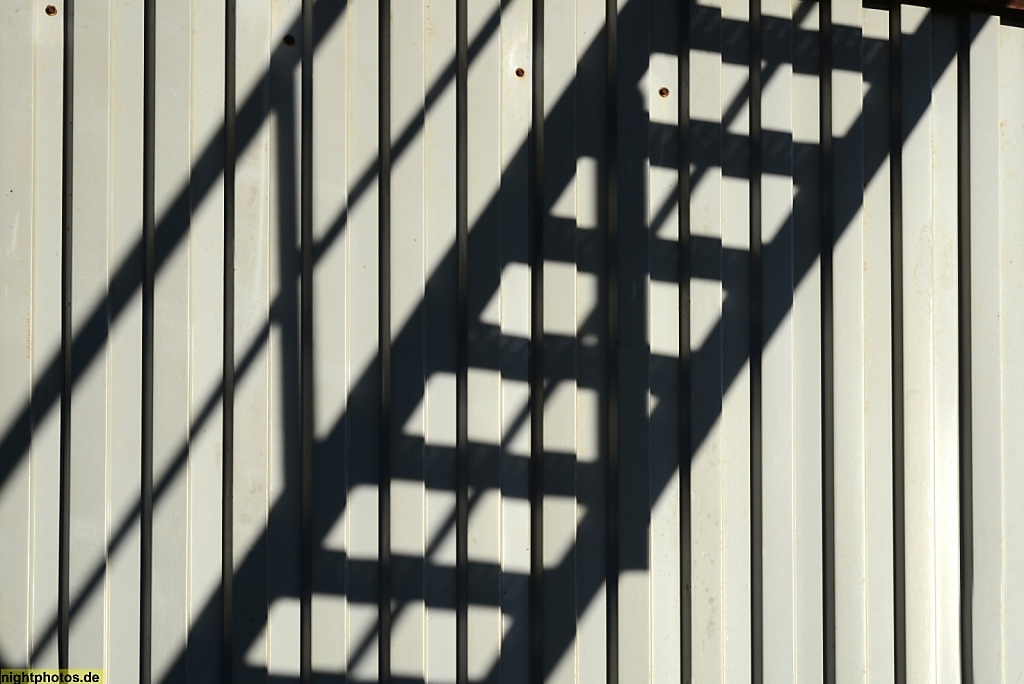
[535,2,581,683]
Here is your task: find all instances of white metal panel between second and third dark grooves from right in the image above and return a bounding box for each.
[833,3,894,681]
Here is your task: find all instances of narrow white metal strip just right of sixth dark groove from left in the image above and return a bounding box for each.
[466,0,505,681]
